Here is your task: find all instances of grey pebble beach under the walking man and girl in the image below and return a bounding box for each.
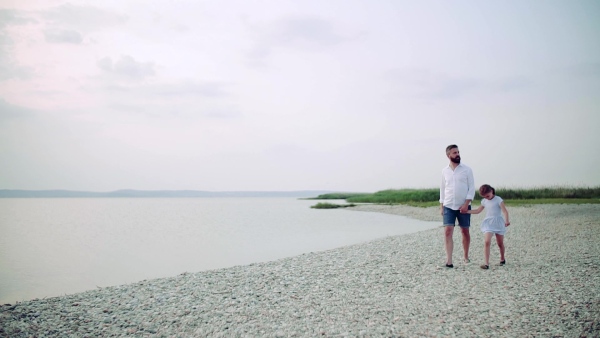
[0,204,600,337]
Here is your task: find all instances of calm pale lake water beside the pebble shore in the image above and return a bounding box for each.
[0,198,438,303]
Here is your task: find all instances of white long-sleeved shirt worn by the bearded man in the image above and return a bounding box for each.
[440,163,475,210]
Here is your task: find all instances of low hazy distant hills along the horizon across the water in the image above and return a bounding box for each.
[0,189,332,198]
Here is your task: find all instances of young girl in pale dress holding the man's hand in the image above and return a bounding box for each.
[467,184,510,270]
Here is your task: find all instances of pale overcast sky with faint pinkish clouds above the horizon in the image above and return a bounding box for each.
[0,0,600,192]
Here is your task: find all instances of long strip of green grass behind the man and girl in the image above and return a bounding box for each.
[314,186,600,207]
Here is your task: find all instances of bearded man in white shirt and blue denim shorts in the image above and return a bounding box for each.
[440,144,475,268]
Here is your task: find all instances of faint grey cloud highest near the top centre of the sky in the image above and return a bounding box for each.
[248,17,349,62]
